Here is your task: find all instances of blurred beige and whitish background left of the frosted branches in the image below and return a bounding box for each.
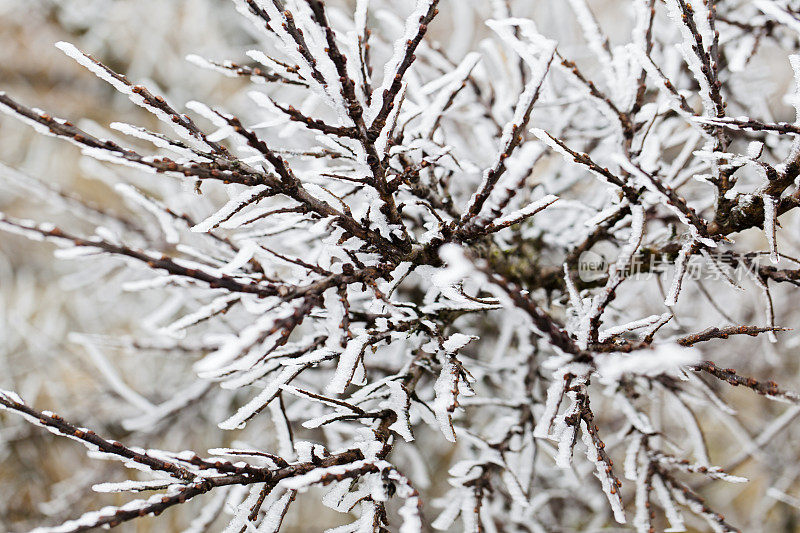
[0,0,262,532]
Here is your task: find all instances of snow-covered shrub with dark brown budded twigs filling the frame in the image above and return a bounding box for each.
[0,0,800,532]
